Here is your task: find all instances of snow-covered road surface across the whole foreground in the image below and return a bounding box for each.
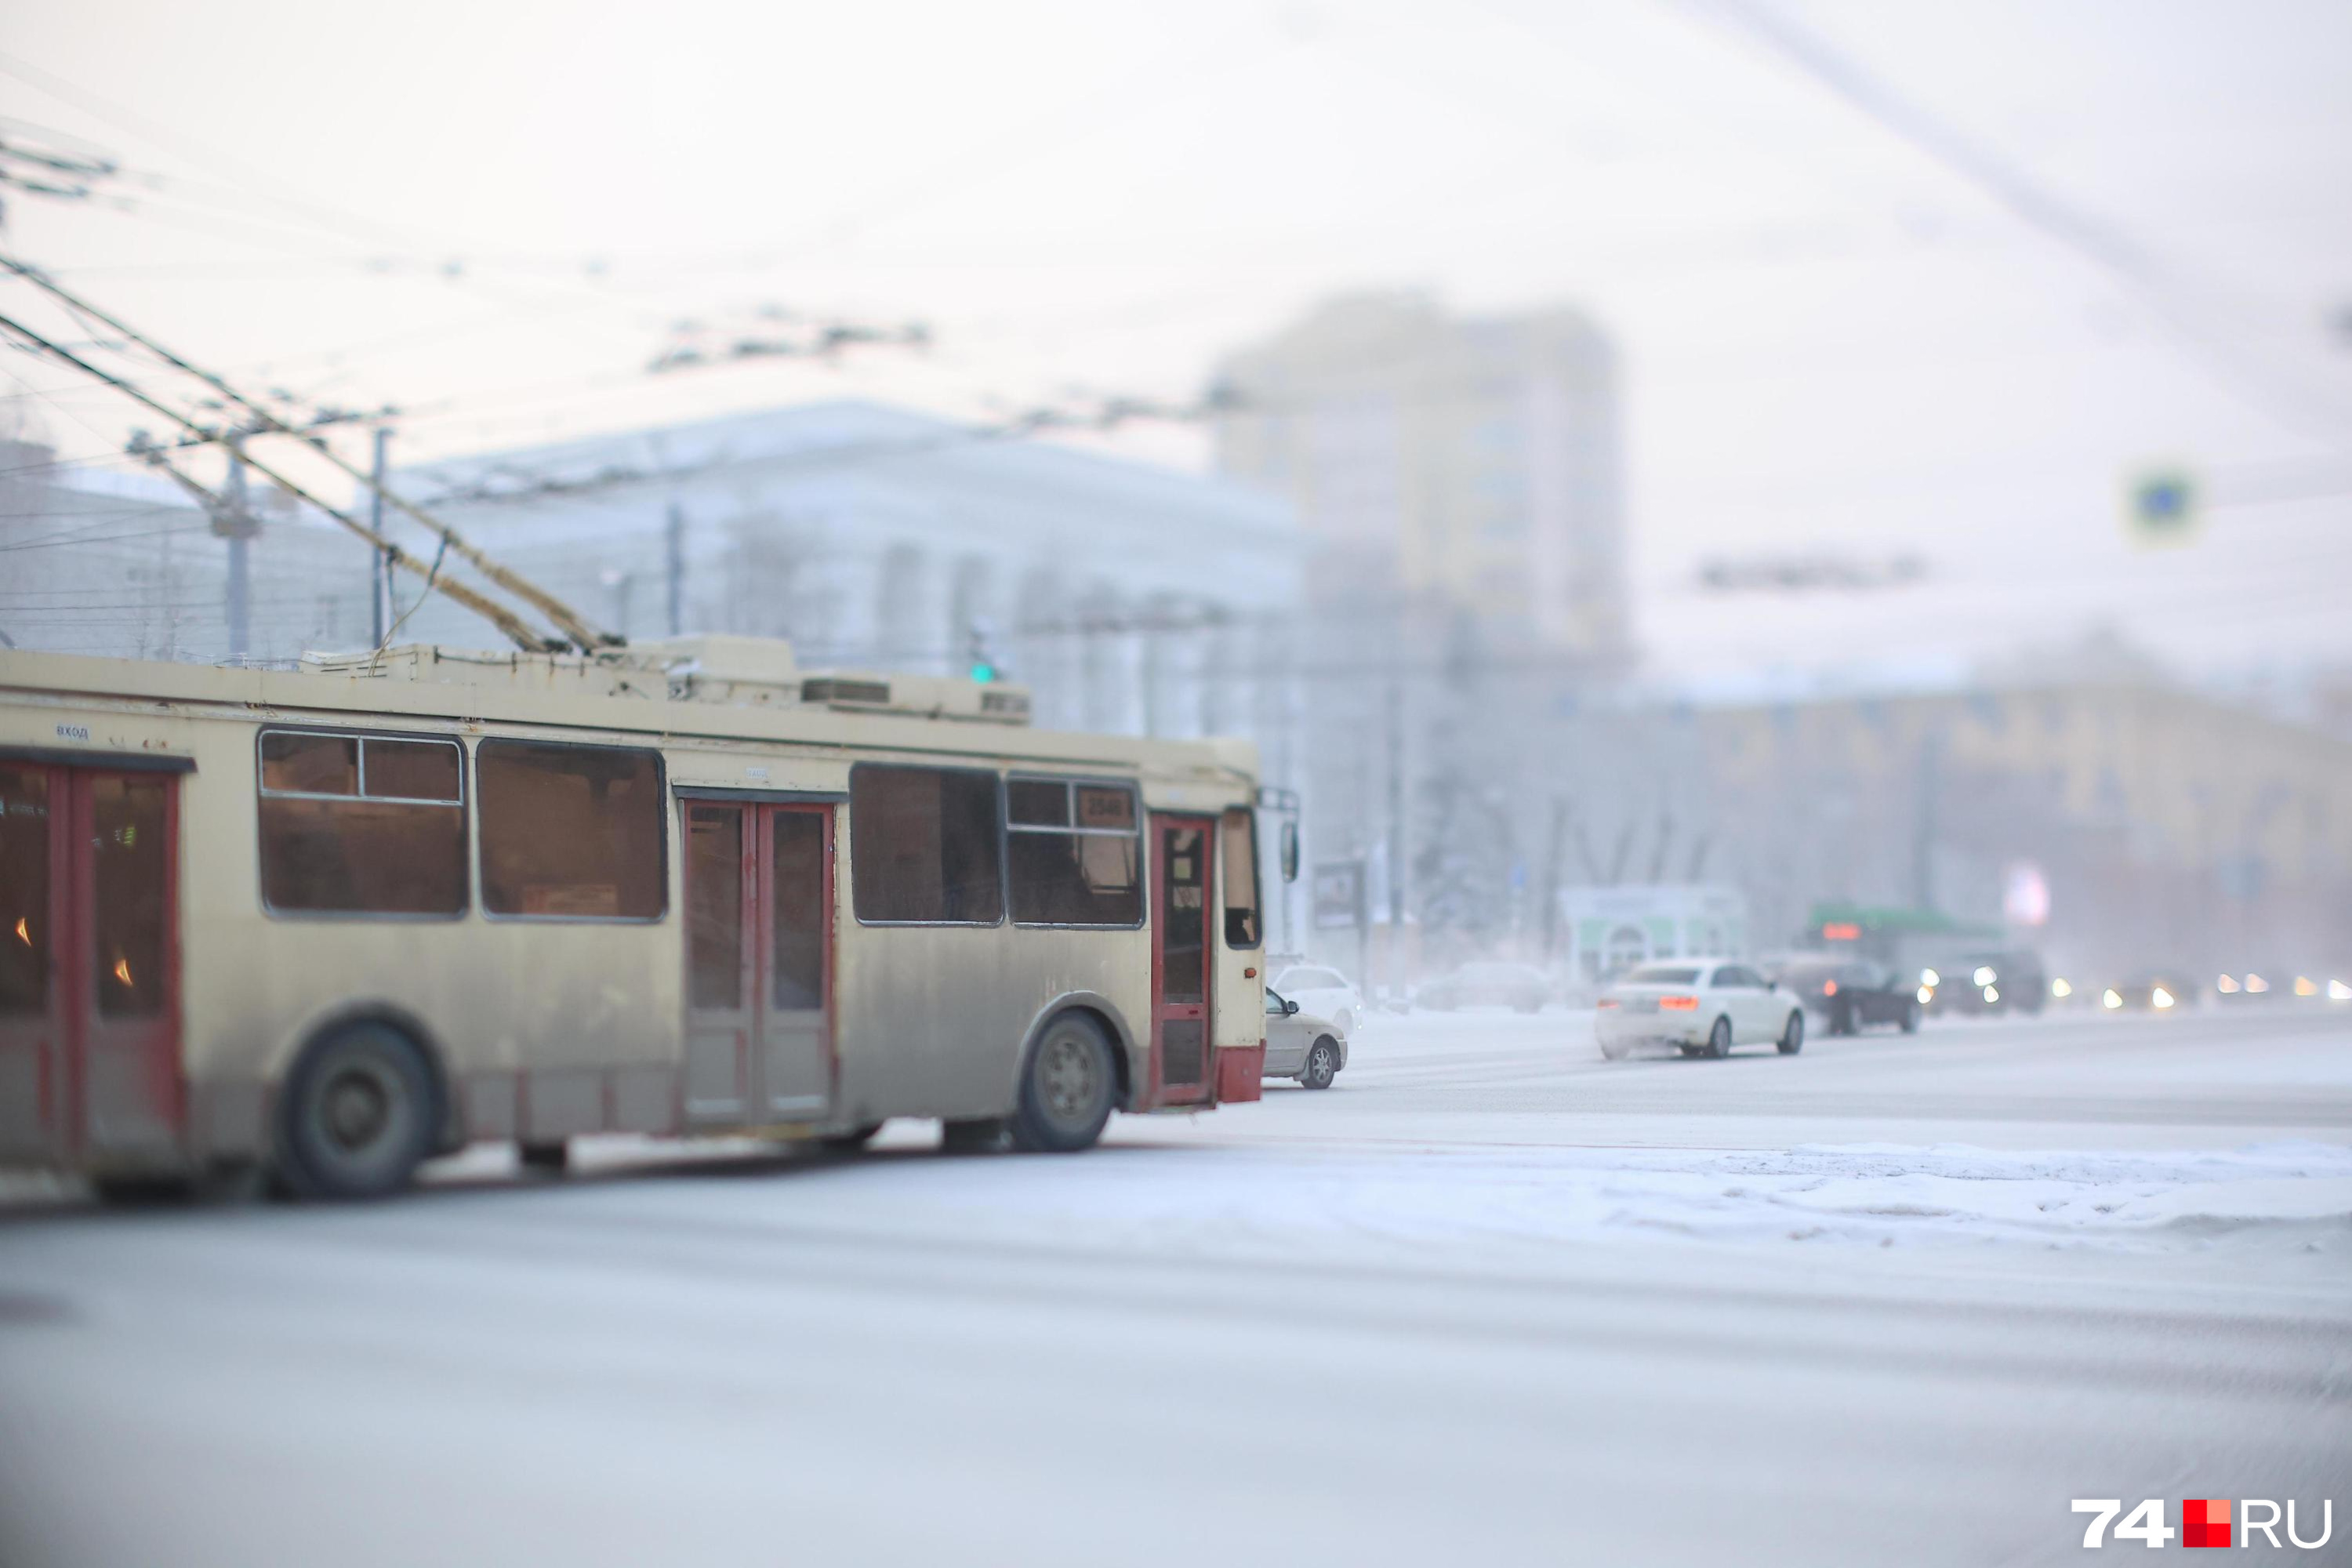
[0,1004,2352,1568]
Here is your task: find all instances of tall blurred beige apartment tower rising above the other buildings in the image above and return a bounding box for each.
[1216,292,1630,980]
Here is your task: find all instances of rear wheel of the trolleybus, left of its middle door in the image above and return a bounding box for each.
[278,1020,437,1199]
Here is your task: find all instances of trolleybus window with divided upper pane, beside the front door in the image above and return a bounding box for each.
[1004,779,1143,931]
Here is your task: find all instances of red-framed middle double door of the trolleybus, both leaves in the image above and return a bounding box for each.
[684,799,833,1126]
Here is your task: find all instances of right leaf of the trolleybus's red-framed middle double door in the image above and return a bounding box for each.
[760,806,833,1121]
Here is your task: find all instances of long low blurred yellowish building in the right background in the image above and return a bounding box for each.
[1538,675,2352,992]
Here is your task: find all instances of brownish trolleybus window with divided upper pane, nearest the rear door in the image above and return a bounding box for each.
[261,729,468,914]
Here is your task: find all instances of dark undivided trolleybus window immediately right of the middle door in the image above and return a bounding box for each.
[849,762,1004,926]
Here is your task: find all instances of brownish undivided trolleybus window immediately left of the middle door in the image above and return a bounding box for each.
[473,741,668,919]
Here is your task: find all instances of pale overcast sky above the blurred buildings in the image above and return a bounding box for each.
[0,0,2352,670]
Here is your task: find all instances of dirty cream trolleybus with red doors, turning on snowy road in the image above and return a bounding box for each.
[0,637,1289,1196]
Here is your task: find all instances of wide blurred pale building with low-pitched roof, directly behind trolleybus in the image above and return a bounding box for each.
[395,402,1303,752]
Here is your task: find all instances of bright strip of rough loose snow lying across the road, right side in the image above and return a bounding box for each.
[884,1142,2352,1253]
